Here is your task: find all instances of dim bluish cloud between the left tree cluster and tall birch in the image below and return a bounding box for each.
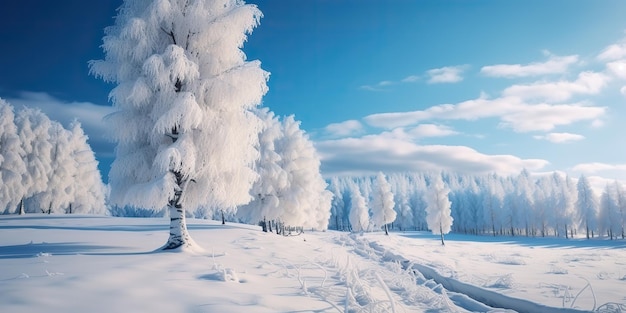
[7,92,114,156]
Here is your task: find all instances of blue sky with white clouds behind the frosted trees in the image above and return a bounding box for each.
[0,0,626,188]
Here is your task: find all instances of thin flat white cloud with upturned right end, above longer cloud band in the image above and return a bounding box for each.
[480,52,578,78]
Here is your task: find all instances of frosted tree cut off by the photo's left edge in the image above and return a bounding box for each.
[0,99,26,214]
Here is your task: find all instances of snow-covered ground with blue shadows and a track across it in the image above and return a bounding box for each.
[0,214,626,313]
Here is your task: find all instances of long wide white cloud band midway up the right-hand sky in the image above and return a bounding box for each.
[364,97,606,132]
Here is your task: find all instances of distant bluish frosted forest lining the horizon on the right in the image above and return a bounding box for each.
[329,170,626,239]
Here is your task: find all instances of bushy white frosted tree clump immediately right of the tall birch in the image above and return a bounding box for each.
[238,108,332,230]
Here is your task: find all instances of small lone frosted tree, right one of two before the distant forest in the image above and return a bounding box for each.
[426,175,453,245]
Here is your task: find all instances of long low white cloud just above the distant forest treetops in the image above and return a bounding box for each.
[316,132,548,176]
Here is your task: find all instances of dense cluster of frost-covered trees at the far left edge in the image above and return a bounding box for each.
[0,99,107,214]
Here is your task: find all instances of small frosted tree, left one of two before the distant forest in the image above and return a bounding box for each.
[370,172,396,235]
